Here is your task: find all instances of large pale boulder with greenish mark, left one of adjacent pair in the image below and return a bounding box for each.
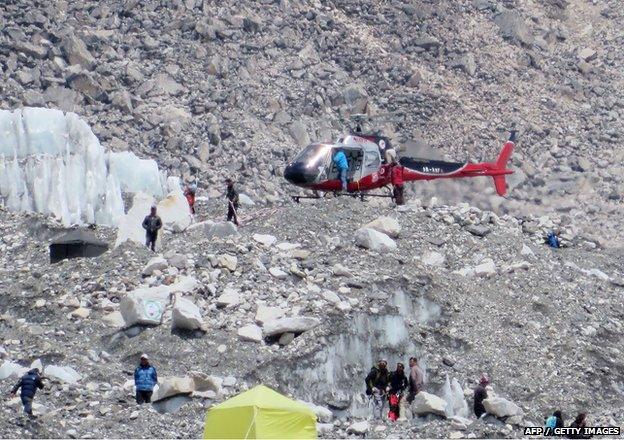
[119,286,170,326]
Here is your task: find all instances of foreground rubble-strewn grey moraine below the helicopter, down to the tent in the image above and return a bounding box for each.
[0,198,624,437]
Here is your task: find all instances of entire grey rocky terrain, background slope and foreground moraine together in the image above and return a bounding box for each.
[0,0,624,438]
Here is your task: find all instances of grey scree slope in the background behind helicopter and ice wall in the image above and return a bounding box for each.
[0,0,624,246]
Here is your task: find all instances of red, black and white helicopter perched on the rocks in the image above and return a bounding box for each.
[284,114,516,202]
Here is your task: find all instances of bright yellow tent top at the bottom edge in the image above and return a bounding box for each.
[204,385,316,439]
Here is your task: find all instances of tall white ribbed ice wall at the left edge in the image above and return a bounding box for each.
[0,107,163,226]
